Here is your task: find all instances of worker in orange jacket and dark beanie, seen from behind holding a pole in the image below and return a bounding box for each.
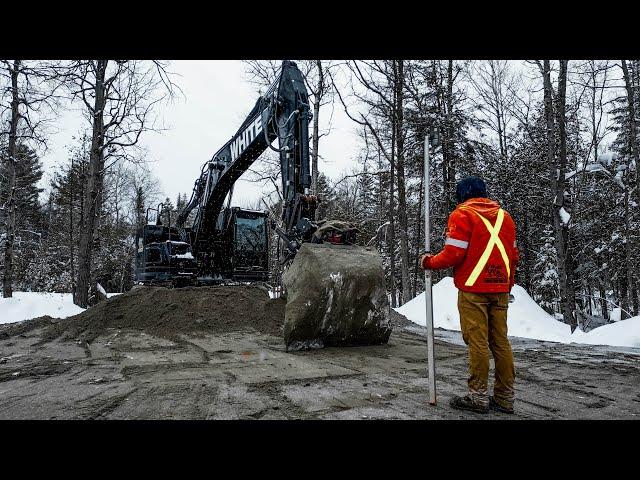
[420,177,518,413]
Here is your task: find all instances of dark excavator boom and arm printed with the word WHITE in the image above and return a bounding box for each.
[177,60,316,250]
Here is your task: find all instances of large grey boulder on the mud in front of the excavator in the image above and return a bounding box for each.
[283,243,392,350]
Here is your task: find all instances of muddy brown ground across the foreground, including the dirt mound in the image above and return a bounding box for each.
[0,287,640,419]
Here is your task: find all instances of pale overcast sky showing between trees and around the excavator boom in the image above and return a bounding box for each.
[42,60,357,206]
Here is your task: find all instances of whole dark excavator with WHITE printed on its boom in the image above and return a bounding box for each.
[135,60,357,287]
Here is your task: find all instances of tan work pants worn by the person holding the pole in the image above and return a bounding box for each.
[458,291,515,407]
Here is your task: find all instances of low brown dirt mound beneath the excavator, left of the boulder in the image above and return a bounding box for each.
[2,285,286,343]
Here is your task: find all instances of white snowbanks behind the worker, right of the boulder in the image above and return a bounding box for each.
[395,277,640,348]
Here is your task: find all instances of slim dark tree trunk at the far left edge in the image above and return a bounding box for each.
[2,60,20,298]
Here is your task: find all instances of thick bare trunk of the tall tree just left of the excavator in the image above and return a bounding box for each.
[74,60,108,308]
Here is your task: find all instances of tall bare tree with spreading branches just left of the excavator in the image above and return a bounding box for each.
[68,60,174,308]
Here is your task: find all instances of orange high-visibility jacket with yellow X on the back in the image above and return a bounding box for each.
[423,198,519,293]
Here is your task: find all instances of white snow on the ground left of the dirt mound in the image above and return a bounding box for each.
[0,292,118,323]
